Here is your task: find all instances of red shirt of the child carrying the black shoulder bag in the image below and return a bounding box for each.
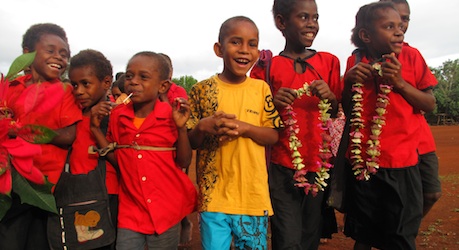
[70,116,118,194]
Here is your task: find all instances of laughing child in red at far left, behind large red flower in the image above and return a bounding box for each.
[0,23,81,249]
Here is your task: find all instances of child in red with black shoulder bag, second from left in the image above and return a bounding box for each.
[69,49,119,248]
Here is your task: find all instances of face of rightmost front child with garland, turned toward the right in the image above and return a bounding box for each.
[364,8,404,58]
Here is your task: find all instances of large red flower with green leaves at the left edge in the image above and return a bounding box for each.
[0,52,59,220]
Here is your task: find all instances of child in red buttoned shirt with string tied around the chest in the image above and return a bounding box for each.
[91,52,196,249]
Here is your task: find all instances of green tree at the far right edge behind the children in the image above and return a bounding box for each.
[432,59,459,116]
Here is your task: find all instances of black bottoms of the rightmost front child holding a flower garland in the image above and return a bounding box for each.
[344,162,423,250]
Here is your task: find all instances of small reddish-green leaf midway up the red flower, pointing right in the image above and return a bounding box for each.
[16,124,57,144]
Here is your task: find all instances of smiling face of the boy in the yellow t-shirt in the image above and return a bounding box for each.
[214,20,259,82]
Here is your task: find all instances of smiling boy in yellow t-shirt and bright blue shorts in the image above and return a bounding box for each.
[187,16,280,249]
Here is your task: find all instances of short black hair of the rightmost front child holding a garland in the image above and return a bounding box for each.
[351,1,397,49]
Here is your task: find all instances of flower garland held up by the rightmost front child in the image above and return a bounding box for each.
[349,63,392,181]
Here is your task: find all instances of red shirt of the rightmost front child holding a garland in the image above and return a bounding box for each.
[346,46,438,168]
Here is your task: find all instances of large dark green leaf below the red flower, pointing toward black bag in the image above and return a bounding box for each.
[11,168,57,213]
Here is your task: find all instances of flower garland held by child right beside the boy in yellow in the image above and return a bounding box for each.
[285,82,333,196]
